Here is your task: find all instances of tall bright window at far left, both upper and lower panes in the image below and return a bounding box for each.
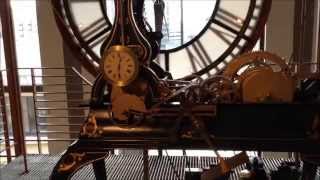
[0,0,42,155]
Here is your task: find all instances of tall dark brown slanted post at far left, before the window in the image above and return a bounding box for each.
[0,0,28,172]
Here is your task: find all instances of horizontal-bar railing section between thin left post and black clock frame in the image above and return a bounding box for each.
[30,68,91,154]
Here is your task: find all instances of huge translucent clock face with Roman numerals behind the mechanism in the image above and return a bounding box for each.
[52,0,271,79]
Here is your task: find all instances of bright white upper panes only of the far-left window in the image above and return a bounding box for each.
[0,0,41,86]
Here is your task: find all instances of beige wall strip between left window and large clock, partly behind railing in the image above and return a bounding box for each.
[37,0,69,154]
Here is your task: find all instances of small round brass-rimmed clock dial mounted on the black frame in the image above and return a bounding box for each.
[101,46,139,87]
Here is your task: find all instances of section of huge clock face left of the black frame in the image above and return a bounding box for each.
[52,0,112,75]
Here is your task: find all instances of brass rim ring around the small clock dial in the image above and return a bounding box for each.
[100,45,140,87]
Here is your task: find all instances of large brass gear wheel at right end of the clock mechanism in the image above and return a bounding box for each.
[223,52,295,103]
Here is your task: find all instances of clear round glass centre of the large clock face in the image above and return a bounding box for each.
[145,0,216,50]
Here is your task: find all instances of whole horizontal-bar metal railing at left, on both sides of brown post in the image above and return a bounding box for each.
[0,67,91,159]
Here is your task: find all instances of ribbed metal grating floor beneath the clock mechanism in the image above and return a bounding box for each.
[0,155,319,180]
